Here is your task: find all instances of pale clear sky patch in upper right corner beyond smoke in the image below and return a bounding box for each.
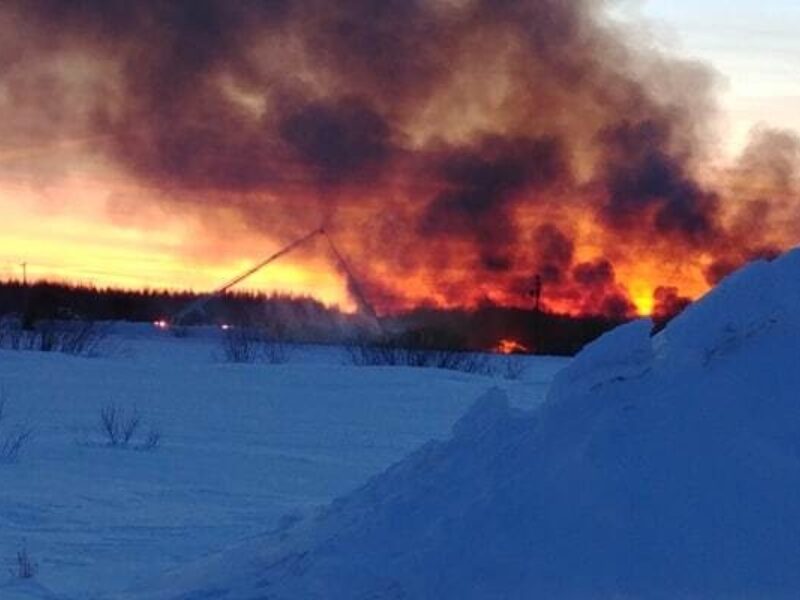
[636,0,800,151]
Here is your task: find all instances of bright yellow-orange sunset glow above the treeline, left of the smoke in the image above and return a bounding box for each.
[0,176,354,310]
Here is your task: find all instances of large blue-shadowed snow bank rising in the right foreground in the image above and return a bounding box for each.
[138,251,800,600]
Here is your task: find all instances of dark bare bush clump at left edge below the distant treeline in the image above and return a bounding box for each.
[0,317,108,356]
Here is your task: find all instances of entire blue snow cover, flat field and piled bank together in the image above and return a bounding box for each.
[6,250,800,600]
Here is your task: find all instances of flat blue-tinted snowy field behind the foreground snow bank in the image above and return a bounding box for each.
[0,327,567,600]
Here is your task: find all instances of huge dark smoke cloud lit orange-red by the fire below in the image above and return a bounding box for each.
[0,0,800,317]
